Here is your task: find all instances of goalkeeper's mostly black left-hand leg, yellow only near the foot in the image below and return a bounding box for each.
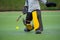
[23,12,33,32]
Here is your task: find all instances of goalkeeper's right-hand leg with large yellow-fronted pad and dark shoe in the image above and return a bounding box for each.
[32,10,43,34]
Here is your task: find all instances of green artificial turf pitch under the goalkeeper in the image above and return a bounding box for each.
[0,11,60,40]
